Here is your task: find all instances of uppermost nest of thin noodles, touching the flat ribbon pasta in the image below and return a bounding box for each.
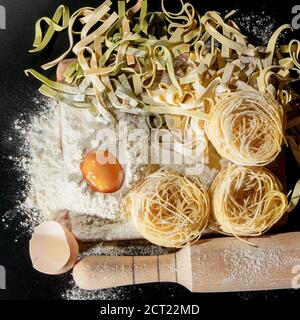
[206,90,284,166]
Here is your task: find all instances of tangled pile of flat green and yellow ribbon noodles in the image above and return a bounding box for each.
[26,0,300,164]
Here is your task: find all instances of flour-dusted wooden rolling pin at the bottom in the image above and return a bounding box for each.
[73,232,300,292]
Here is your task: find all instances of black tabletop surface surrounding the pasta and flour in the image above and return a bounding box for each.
[0,0,300,304]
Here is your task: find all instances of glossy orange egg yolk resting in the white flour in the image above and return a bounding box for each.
[80,151,124,193]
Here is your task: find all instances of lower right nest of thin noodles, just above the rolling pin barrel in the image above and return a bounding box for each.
[210,165,288,237]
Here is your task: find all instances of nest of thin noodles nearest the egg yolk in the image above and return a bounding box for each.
[127,169,210,248]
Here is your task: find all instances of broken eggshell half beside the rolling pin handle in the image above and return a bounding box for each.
[29,221,79,275]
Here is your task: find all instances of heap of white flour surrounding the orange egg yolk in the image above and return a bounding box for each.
[21,101,148,219]
